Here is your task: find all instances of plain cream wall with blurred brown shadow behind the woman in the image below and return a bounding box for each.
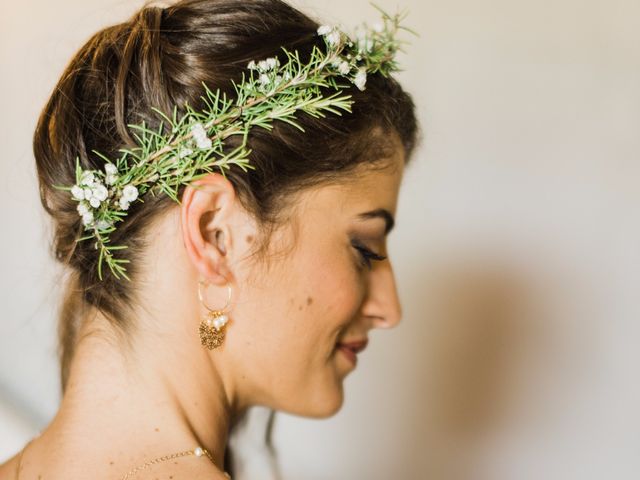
[0,0,640,480]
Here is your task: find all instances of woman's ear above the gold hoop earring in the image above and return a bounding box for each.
[180,173,239,285]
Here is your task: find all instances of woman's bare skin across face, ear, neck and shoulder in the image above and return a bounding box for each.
[0,141,404,480]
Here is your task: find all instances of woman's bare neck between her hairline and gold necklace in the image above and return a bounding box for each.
[36,310,243,470]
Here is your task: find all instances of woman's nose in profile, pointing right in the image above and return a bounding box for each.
[363,260,402,328]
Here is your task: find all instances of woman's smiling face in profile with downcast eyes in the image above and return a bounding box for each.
[226,149,404,417]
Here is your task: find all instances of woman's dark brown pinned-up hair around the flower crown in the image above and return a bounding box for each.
[33,0,417,472]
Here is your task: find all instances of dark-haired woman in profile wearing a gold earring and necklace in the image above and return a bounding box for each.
[0,0,417,479]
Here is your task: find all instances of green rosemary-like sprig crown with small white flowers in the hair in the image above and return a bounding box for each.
[55,6,416,280]
